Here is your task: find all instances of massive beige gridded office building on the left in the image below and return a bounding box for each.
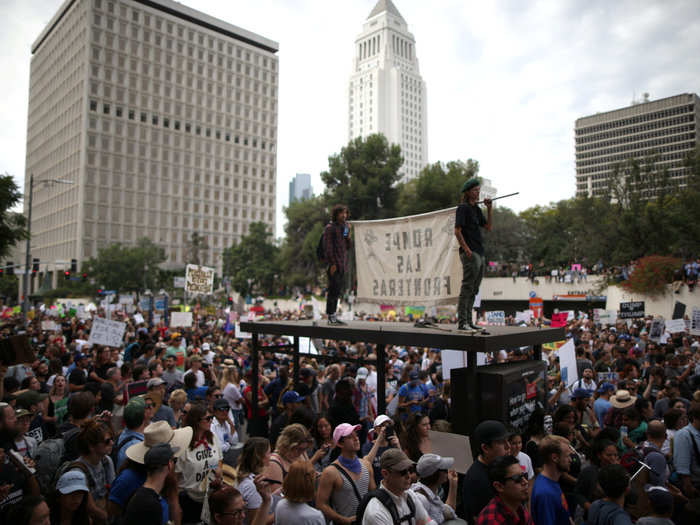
[25,0,279,282]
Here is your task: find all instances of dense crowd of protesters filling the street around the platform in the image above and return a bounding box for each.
[0,302,700,525]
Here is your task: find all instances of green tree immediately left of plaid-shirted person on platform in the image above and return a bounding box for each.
[280,196,329,287]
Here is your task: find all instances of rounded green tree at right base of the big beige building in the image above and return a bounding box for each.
[223,222,280,295]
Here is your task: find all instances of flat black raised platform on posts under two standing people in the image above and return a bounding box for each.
[241,320,566,434]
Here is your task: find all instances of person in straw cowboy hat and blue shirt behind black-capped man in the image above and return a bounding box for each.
[107,421,192,517]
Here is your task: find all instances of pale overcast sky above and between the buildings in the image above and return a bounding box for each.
[0,0,700,235]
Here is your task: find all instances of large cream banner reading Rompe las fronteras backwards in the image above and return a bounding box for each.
[352,208,462,306]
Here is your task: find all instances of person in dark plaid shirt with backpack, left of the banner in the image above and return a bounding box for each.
[323,204,351,325]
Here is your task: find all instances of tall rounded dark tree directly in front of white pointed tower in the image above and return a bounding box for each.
[321,134,403,219]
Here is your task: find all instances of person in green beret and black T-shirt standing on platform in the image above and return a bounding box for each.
[455,177,493,330]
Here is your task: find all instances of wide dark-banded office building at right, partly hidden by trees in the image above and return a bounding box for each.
[575,93,700,196]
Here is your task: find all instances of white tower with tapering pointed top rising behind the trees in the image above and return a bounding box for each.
[348,0,428,179]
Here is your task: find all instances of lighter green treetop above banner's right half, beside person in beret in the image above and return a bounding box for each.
[397,159,479,216]
